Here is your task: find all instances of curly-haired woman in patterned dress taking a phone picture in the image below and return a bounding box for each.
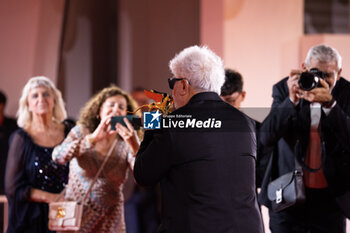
[53,86,139,233]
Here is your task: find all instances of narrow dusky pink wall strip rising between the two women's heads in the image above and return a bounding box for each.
[56,1,93,119]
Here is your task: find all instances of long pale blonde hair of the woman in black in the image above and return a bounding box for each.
[17,76,67,128]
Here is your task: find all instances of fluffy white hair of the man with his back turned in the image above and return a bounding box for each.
[169,45,225,95]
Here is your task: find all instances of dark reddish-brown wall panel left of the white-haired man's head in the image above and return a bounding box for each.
[118,0,200,91]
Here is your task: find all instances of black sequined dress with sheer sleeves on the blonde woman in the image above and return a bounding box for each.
[5,125,70,233]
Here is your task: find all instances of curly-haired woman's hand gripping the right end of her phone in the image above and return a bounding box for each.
[116,117,140,155]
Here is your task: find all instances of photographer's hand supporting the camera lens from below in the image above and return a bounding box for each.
[297,79,332,103]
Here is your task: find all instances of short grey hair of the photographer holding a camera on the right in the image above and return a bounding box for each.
[305,44,342,71]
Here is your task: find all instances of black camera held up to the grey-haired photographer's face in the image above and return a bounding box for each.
[298,68,326,91]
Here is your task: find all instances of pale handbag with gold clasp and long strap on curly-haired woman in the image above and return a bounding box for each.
[49,140,117,231]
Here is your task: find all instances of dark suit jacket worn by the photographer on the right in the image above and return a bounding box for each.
[259,78,350,217]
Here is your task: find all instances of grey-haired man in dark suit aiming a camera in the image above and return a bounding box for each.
[259,45,350,233]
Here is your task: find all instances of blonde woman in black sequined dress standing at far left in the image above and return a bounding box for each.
[5,76,71,233]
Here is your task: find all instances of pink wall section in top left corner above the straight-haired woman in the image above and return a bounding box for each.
[0,0,40,116]
